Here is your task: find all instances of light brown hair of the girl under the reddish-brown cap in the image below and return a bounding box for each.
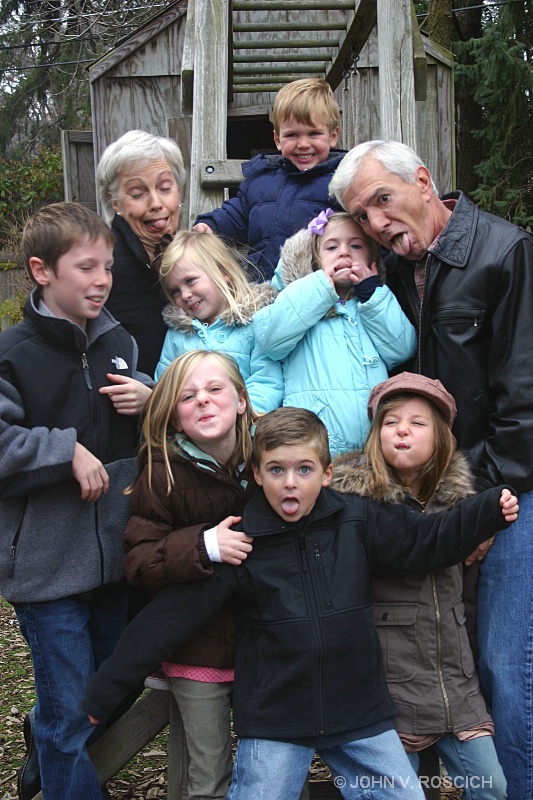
[363,392,456,503]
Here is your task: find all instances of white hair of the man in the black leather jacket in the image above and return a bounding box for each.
[329,139,438,208]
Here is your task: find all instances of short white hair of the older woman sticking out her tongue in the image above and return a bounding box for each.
[96,131,187,224]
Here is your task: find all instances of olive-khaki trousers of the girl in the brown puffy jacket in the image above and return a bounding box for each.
[169,678,233,800]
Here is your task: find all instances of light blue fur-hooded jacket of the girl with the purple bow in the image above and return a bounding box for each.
[253,230,416,455]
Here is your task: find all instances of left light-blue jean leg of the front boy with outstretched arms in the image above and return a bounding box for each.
[227,739,314,800]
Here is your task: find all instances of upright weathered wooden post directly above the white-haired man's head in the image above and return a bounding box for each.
[377,0,417,150]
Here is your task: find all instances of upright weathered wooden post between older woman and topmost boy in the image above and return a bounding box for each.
[189,0,229,224]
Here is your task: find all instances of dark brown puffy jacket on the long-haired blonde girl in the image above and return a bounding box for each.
[124,453,254,669]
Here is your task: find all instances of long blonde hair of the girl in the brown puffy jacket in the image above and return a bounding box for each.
[132,350,257,494]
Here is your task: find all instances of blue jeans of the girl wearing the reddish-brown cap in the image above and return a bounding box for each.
[408,734,507,800]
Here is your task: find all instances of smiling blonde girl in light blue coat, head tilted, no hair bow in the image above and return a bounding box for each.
[155,231,283,412]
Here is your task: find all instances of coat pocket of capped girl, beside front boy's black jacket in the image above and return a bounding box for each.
[373,603,418,683]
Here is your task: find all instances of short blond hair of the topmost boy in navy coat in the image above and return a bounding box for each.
[272,78,340,135]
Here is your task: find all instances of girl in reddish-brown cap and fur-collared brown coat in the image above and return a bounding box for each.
[331,372,506,800]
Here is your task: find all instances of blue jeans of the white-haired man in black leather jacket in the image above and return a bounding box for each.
[478,492,533,800]
